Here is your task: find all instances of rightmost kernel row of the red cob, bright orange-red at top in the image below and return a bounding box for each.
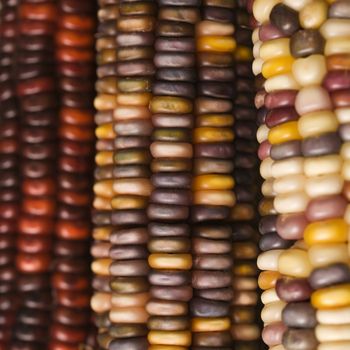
[49,1,95,349]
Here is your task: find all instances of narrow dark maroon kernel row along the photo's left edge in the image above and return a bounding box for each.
[0,1,20,350]
